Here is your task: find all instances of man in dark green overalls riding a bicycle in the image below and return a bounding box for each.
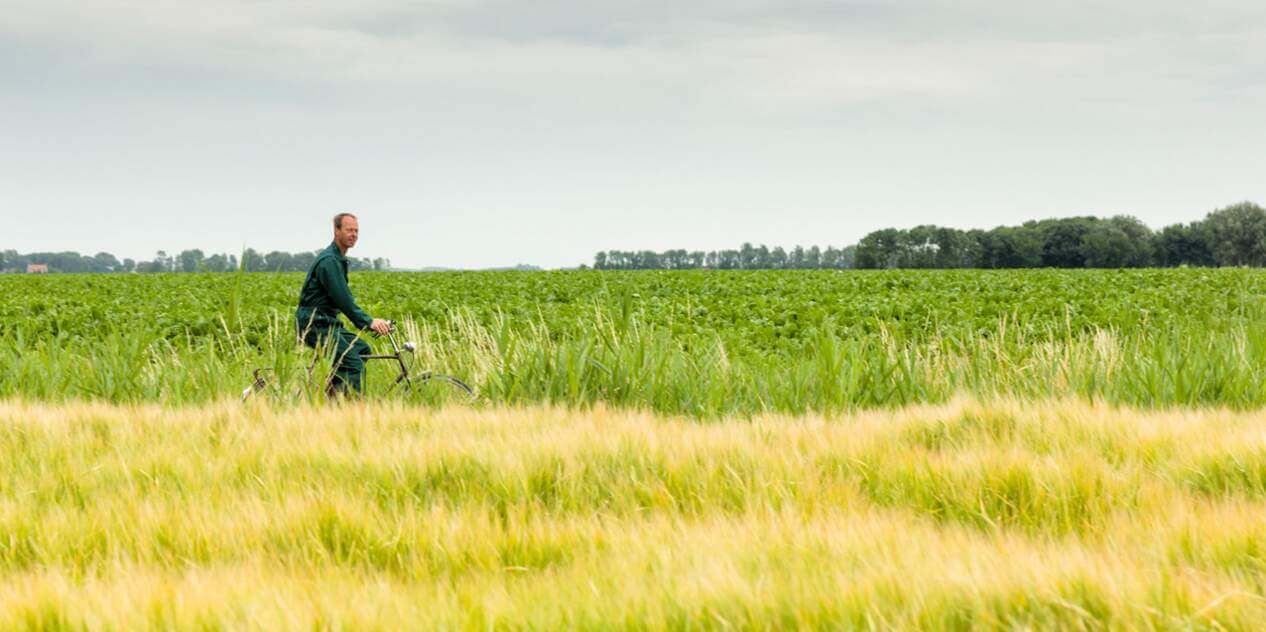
[295,213,391,395]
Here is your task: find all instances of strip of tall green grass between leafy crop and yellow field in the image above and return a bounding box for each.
[0,308,1266,418]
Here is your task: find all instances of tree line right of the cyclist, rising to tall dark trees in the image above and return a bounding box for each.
[594,201,1266,270]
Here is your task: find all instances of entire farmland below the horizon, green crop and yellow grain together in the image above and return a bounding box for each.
[0,269,1266,629]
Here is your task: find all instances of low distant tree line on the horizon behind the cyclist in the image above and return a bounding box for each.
[0,248,391,272]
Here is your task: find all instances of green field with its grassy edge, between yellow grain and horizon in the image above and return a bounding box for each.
[0,270,1266,418]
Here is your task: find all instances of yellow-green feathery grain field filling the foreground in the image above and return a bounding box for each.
[0,399,1266,629]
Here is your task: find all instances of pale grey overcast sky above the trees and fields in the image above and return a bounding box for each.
[0,0,1266,267]
